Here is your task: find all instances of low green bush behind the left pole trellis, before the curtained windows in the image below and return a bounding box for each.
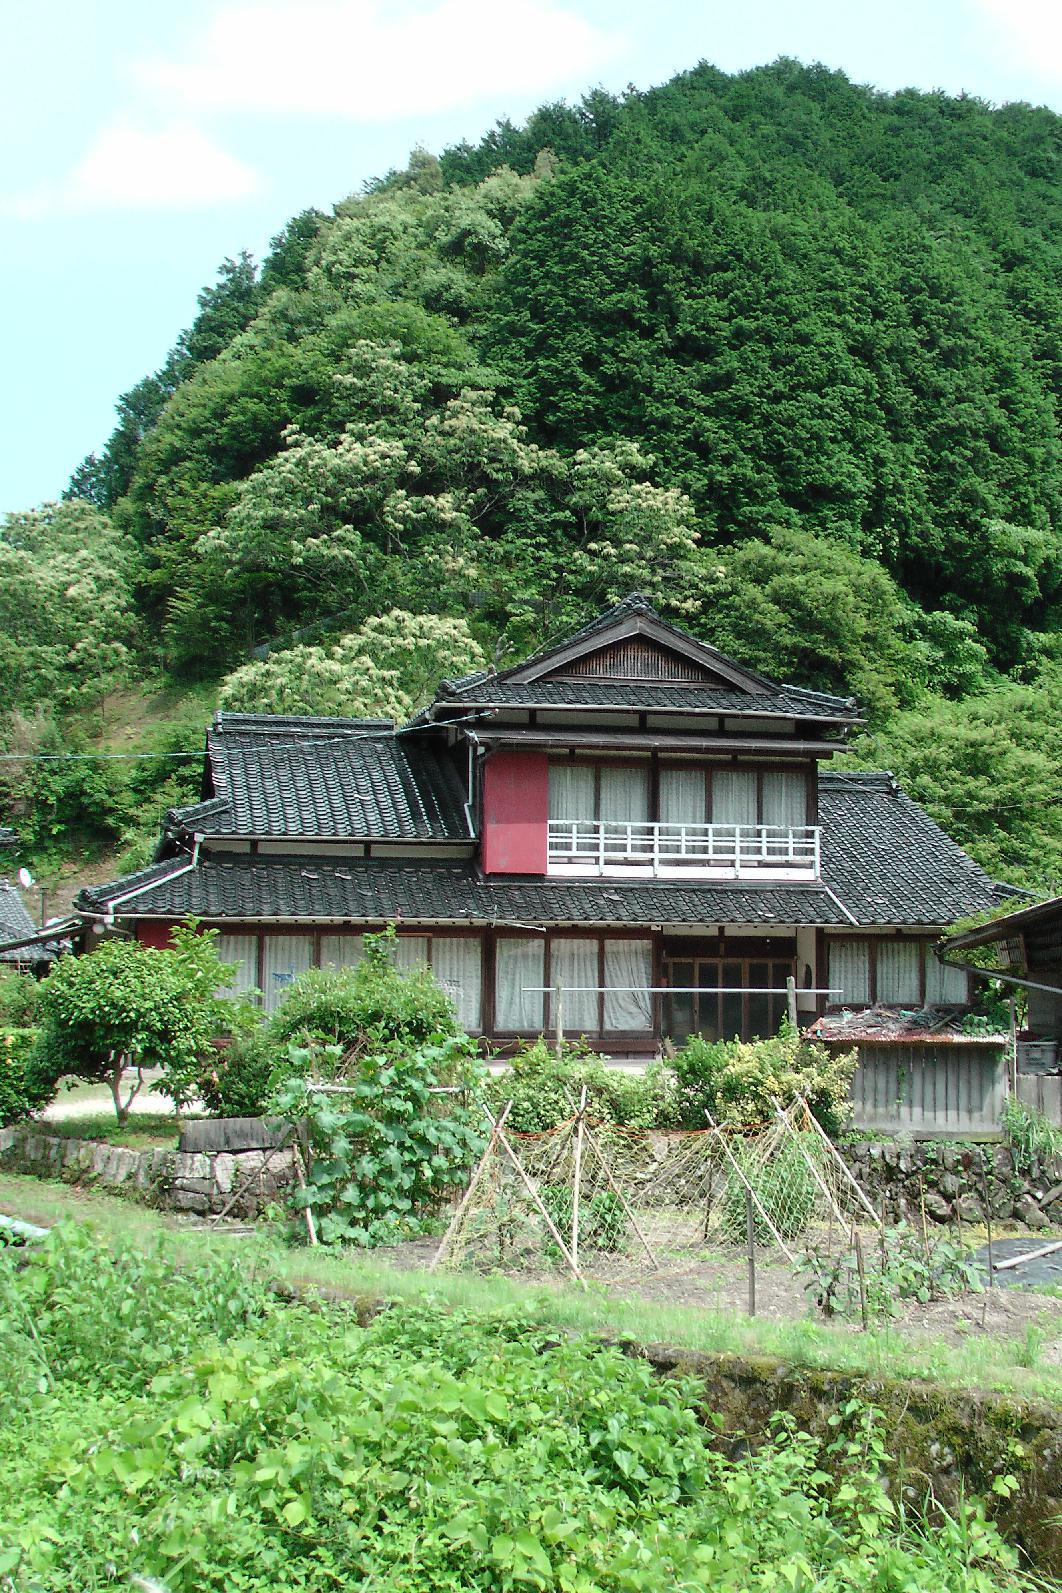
[486,1039,675,1133]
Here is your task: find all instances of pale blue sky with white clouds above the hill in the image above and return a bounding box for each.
[0,0,1062,508]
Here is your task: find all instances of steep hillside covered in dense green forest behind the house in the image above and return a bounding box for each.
[0,61,1062,886]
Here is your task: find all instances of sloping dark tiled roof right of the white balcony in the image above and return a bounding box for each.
[818,769,1006,926]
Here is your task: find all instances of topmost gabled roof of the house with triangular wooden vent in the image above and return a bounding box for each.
[433,593,860,723]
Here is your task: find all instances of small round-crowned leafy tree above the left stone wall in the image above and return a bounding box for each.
[30,924,236,1123]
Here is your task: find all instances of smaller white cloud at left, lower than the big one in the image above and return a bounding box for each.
[6,118,261,217]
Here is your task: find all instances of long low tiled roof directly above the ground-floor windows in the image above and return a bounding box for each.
[78,854,845,926]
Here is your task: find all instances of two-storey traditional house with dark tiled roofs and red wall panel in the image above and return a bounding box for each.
[76,596,997,1056]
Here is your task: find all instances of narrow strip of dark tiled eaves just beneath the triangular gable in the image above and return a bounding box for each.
[439,675,855,720]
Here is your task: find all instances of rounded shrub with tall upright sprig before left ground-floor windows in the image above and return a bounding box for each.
[269,929,457,1047]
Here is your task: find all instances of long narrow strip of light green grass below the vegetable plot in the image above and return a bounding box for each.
[0,1174,1062,1402]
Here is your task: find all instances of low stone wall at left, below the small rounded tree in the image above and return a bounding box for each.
[0,1128,295,1217]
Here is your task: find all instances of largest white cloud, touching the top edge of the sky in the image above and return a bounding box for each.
[135,0,624,121]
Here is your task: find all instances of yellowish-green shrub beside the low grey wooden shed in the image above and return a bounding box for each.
[672,1024,857,1134]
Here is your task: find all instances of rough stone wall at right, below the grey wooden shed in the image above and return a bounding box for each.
[842,1139,1062,1228]
